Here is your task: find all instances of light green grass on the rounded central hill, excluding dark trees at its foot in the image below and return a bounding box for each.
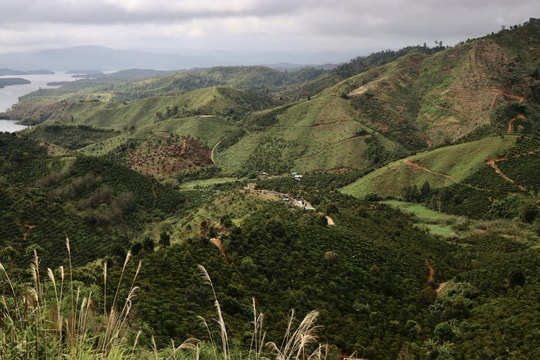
[217,95,374,172]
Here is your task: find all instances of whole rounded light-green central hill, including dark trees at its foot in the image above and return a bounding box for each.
[217,96,384,174]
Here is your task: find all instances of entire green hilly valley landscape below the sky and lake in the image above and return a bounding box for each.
[0,21,540,359]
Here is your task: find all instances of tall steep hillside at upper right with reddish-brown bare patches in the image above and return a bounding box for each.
[327,22,540,149]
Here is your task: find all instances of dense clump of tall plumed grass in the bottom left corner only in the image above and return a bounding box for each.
[0,239,140,359]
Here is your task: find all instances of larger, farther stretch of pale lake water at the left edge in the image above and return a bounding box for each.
[0,72,76,112]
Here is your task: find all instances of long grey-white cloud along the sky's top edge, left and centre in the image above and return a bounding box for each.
[2,0,317,25]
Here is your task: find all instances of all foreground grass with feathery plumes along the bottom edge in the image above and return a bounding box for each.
[0,239,326,360]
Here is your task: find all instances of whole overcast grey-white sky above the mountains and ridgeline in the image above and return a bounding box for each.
[0,0,540,55]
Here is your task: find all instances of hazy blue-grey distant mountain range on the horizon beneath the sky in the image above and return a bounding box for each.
[0,46,362,71]
